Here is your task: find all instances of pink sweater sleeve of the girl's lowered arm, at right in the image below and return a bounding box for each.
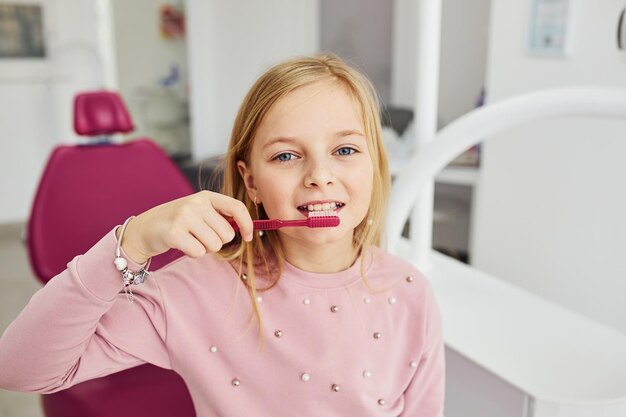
[400,285,445,417]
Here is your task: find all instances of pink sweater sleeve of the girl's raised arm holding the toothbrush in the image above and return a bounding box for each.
[0,230,171,394]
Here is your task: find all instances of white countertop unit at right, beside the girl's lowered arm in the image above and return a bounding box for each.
[400,240,626,417]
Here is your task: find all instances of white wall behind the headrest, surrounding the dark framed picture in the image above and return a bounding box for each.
[0,0,105,223]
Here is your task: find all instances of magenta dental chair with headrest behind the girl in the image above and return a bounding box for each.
[27,91,195,417]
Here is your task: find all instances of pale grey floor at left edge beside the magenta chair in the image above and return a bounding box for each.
[0,224,43,417]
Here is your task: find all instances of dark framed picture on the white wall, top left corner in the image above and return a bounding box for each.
[0,3,46,59]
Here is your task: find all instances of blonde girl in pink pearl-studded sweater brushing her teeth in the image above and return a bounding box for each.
[0,55,444,417]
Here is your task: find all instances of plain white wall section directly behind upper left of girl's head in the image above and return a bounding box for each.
[186,0,319,160]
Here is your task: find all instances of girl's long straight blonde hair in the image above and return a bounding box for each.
[212,53,391,342]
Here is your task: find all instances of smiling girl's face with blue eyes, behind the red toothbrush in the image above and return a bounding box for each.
[238,81,374,249]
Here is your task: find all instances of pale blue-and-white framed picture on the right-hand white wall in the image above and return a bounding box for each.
[528,0,573,57]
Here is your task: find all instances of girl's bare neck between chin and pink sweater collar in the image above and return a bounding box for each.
[283,236,358,273]
